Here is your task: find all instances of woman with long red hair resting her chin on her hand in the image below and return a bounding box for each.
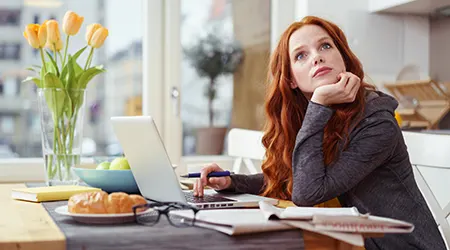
[194,16,445,249]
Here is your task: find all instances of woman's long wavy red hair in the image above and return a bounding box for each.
[262,16,373,200]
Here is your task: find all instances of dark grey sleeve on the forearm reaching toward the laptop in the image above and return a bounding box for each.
[216,174,264,195]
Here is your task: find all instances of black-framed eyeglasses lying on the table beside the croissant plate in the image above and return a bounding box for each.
[133,202,200,227]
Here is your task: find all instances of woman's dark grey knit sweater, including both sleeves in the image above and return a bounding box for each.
[222,92,445,250]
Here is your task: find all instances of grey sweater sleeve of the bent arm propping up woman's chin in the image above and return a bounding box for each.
[292,102,398,206]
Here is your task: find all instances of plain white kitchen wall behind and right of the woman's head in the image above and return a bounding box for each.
[297,0,430,90]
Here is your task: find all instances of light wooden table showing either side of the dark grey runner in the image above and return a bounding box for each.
[0,184,361,250]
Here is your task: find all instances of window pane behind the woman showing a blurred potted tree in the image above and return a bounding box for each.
[181,0,270,155]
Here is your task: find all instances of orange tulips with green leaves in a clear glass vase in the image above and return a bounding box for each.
[23,11,108,185]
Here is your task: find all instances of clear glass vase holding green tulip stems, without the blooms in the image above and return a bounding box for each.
[38,88,86,186]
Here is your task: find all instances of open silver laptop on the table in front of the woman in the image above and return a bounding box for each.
[111,116,278,208]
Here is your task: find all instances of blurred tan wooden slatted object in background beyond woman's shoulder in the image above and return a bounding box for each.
[384,80,450,129]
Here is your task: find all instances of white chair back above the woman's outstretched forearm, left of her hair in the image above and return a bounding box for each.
[228,128,266,174]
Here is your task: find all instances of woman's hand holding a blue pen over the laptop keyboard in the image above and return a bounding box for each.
[193,163,231,197]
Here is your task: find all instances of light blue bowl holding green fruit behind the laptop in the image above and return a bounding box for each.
[73,168,139,194]
